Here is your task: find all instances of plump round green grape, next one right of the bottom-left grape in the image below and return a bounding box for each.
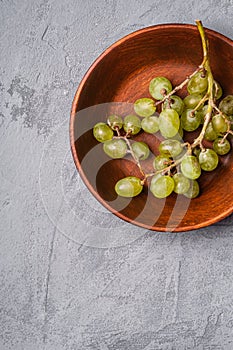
[150,175,175,198]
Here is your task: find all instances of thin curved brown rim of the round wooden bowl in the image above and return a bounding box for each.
[69,23,233,232]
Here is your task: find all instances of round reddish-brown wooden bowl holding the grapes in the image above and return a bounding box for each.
[70,24,233,231]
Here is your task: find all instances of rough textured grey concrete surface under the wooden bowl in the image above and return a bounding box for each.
[0,0,233,350]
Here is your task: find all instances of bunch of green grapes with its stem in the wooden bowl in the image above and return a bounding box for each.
[93,21,233,198]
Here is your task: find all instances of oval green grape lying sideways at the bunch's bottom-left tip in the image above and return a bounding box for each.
[115,176,143,198]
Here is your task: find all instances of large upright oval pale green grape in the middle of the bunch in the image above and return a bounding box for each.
[159,108,180,137]
